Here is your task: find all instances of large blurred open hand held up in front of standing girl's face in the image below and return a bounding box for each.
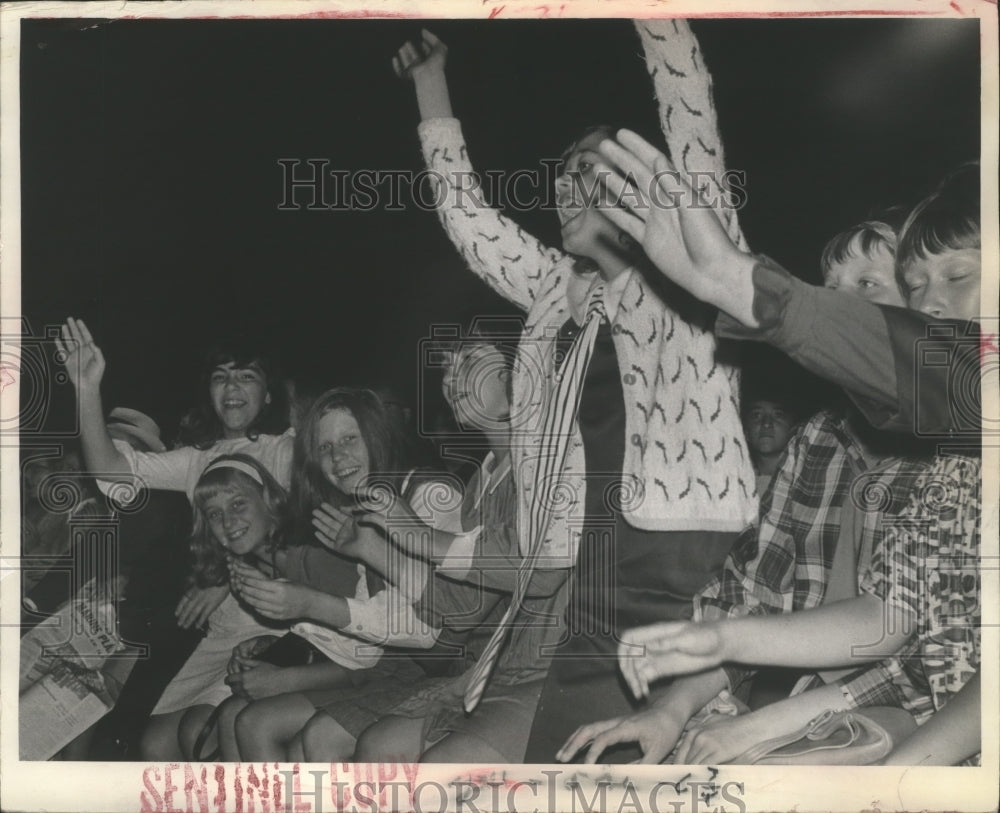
[597,130,756,326]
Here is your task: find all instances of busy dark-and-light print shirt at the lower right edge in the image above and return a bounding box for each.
[838,457,982,723]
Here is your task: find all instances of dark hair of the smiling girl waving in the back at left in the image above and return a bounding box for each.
[175,337,288,449]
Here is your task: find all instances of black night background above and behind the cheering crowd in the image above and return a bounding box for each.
[21,15,979,437]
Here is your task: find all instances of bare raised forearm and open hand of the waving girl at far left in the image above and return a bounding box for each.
[56,316,132,480]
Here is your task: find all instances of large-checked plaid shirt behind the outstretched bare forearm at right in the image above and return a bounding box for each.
[694,411,868,689]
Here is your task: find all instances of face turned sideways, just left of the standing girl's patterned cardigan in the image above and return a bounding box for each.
[443,344,510,432]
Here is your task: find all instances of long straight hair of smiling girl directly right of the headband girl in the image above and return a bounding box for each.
[291,387,410,538]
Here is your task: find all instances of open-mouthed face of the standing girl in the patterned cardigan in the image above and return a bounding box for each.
[556,132,619,258]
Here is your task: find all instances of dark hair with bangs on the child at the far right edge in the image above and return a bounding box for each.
[896,161,982,276]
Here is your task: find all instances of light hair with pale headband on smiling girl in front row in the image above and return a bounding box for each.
[191,454,290,587]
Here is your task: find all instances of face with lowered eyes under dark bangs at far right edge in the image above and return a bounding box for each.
[903,248,982,320]
